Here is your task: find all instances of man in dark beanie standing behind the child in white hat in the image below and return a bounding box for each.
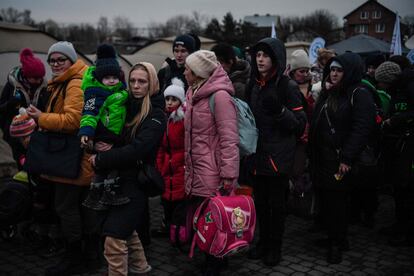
[158,34,196,92]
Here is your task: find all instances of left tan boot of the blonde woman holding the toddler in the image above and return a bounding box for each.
[104,237,128,276]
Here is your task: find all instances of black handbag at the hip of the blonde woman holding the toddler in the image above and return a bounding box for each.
[137,162,164,197]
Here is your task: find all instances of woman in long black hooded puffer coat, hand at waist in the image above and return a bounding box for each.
[309,53,375,263]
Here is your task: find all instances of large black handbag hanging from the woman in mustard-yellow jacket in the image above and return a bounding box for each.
[24,131,83,179]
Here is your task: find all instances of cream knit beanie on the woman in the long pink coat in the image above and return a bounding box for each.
[185,50,218,79]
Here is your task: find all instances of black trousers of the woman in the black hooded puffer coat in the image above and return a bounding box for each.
[320,189,349,245]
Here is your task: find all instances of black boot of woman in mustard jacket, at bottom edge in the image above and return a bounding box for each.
[45,241,84,276]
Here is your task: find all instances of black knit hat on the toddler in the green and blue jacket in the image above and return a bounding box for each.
[95,44,121,82]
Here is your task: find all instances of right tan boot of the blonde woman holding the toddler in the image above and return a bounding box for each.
[127,231,151,274]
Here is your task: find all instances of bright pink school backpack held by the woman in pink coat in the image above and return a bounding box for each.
[190,195,256,257]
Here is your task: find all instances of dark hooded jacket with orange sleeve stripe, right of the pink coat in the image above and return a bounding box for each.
[246,38,306,176]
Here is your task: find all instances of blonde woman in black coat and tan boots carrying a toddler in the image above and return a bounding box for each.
[90,62,166,275]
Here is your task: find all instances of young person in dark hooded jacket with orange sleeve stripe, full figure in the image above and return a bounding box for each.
[246,38,306,266]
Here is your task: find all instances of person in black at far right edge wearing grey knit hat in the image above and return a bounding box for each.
[375,62,414,246]
